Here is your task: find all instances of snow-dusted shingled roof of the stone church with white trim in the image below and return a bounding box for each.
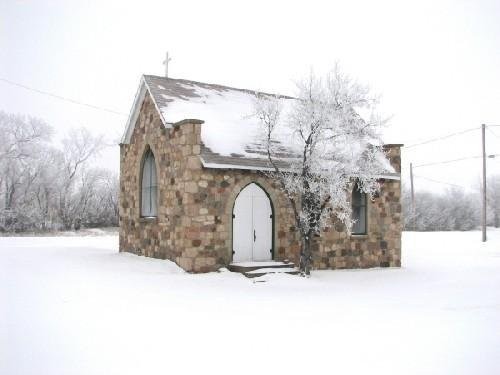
[122,75,399,177]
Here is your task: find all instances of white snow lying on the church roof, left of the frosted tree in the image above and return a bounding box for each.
[144,76,294,158]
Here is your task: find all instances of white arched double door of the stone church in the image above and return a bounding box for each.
[233,183,273,262]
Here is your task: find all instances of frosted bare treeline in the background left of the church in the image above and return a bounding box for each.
[0,111,119,232]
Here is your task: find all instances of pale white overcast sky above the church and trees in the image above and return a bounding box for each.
[0,0,500,189]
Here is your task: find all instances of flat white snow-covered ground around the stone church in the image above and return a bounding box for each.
[0,231,500,375]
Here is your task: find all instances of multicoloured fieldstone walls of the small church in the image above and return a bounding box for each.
[120,91,401,272]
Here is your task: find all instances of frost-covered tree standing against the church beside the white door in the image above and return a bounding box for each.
[255,66,388,275]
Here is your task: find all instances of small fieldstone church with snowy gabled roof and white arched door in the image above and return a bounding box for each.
[120,75,402,272]
